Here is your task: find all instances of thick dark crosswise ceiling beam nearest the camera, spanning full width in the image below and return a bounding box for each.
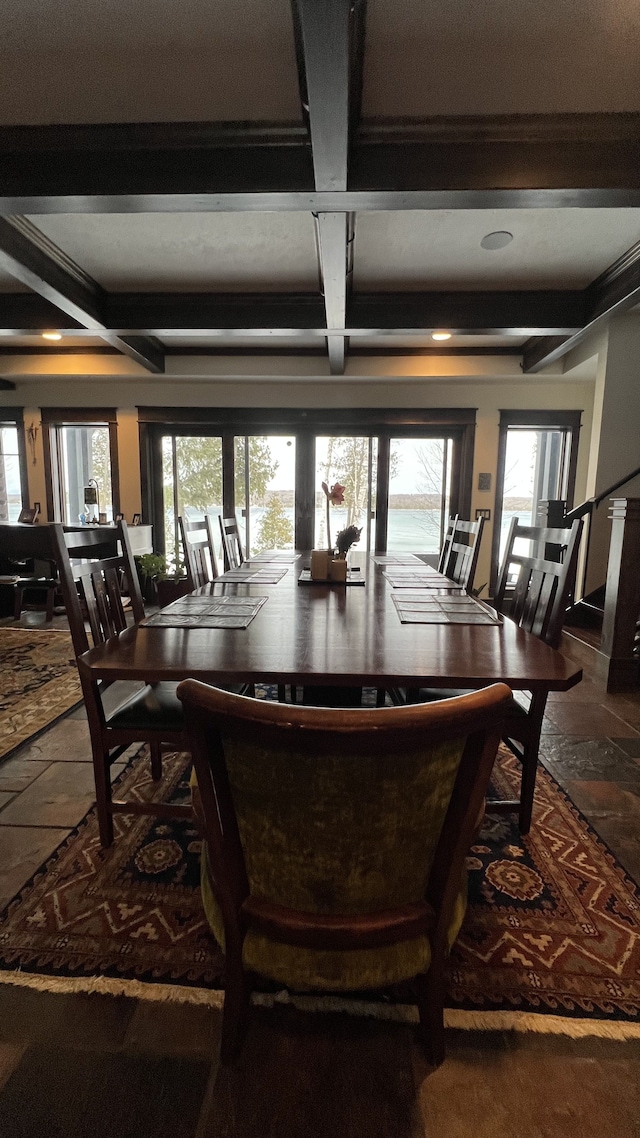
[0,113,640,215]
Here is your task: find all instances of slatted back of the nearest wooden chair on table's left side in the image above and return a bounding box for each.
[58,521,145,655]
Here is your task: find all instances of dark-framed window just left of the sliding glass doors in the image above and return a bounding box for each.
[42,407,120,526]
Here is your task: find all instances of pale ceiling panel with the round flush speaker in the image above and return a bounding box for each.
[353,209,640,291]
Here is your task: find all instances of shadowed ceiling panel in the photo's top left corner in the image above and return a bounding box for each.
[0,0,301,124]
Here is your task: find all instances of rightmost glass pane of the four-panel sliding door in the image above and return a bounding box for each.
[387,438,453,554]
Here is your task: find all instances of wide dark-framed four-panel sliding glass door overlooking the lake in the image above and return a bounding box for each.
[139,407,475,555]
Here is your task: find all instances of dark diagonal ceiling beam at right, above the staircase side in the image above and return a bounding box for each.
[523,241,640,374]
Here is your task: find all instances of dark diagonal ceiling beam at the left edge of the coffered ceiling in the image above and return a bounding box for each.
[0,217,164,372]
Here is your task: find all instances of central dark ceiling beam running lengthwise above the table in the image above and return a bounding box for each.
[293,0,351,376]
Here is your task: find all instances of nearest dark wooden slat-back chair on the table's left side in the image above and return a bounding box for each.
[48,521,190,847]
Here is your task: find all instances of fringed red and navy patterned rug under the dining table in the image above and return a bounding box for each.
[0,747,640,1039]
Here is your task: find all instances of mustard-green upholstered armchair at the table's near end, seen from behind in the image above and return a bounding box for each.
[178,679,510,1063]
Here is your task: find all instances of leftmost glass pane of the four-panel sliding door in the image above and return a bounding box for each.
[162,435,222,570]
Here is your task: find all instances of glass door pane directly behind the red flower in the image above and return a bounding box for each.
[313,435,378,550]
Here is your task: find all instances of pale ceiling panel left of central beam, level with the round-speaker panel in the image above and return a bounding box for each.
[30,213,318,292]
